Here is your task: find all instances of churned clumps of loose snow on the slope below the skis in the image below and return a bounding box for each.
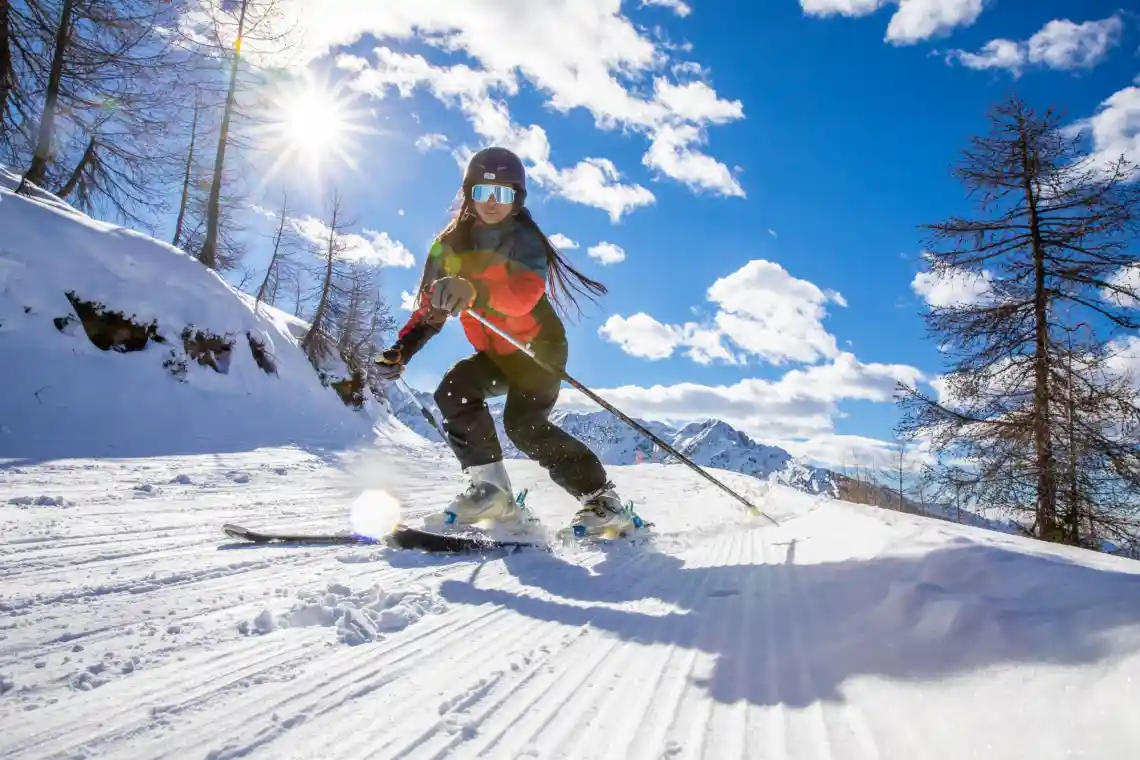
[239,583,447,646]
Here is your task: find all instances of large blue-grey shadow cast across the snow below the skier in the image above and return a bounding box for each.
[440,539,1140,706]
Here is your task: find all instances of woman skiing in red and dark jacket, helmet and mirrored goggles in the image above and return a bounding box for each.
[376,147,634,536]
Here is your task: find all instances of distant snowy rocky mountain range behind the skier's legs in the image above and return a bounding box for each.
[389,386,834,495]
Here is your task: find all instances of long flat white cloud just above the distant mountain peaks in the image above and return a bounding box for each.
[560,350,923,464]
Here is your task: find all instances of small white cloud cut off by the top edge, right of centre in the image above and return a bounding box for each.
[799,0,984,44]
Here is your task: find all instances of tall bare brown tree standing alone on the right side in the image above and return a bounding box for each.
[898,98,1140,544]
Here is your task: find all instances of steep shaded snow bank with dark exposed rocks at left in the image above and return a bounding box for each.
[0,173,402,460]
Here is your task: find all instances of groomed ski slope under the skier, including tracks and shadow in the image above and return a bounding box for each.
[0,443,1140,760]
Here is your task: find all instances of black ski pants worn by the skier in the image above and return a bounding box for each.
[435,345,606,498]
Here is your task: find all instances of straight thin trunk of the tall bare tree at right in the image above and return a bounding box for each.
[1019,127,1058,541]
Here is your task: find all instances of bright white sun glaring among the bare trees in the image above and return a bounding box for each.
[253,75,376,180]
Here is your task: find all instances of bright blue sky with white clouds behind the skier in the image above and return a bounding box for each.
[229,0,1140,466]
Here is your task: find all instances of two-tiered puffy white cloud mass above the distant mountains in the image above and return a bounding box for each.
[579,260,927,466]
